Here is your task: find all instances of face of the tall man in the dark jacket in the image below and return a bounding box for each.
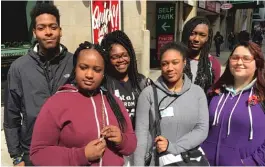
[33,14,62,50]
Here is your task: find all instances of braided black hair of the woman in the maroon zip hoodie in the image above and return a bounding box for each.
[67,41,126,131]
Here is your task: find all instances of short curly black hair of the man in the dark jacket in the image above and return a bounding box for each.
[30,3,60,28]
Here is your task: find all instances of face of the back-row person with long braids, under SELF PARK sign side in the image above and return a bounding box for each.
[188,24,209,51]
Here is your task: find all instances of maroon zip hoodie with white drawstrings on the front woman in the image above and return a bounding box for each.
[30,85,137,166]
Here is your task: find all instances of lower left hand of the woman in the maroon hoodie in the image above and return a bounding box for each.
[85,138,106,161]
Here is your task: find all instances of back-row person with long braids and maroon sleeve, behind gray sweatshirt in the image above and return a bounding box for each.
[181,16,221,92]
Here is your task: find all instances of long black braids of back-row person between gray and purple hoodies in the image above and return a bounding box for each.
[181,16,215,92]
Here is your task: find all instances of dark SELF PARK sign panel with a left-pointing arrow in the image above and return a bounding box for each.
[156,3,175,34]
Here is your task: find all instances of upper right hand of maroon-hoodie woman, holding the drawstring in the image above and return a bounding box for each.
[101,125,122,144]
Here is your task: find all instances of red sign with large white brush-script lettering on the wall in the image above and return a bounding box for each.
[91,0,121,43]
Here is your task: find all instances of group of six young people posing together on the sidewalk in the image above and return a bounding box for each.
[4,3,265,166]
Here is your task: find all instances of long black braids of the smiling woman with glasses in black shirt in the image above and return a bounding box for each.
[101,30,143,94]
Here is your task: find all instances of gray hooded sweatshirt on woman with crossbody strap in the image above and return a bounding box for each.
[133,75,209,166]
